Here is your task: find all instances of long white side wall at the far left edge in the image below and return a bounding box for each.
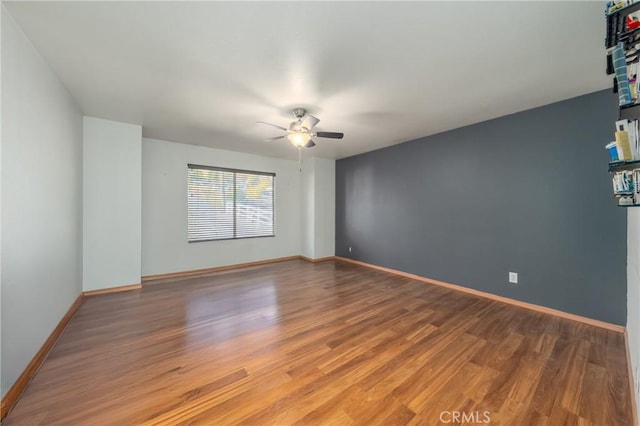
[1,6,82,395]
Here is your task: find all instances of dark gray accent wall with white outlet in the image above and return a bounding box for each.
[336,91,626,325]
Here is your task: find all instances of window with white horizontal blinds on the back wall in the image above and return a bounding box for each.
[187,164,276,243]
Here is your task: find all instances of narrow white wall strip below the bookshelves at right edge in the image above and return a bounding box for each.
[627,208,640,407]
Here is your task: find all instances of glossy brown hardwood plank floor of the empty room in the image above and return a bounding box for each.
[3,260,632,426]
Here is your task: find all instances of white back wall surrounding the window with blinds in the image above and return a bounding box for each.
[142,138,301,276]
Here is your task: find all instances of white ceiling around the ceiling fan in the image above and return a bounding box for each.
[4,1,611,159]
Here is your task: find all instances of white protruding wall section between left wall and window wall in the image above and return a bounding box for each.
[82,117,142,291]
